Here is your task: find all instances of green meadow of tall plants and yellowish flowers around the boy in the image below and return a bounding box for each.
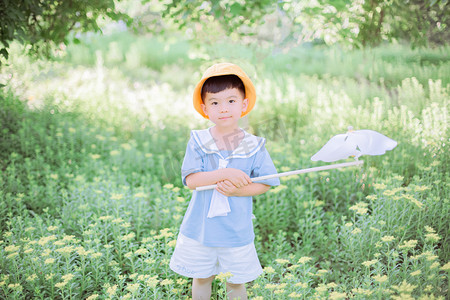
[0,33,450,300]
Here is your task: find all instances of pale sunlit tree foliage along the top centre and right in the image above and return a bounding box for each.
[156,0,450,47]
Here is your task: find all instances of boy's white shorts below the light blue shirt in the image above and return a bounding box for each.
[170,233,262,284]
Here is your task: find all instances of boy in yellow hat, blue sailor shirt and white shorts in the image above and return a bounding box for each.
[170,63,279,300]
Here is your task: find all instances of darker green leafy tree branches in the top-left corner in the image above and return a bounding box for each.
[0,0,129,58]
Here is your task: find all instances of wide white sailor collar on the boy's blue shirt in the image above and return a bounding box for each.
[191,128,265,159]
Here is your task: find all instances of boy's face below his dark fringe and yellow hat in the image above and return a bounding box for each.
[202,88,248,129]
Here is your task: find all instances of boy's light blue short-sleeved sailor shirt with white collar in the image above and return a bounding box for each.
[180,129,280,247]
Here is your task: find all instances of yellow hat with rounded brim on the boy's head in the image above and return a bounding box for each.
[194,63,256,119]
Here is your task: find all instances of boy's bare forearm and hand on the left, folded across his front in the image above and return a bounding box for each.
[186,168,252,190]
